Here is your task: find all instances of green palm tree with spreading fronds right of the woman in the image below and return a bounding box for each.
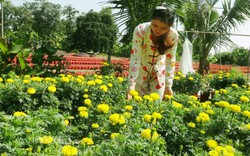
[177,0,250,74]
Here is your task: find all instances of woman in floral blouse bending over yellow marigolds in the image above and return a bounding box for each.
[127,6,178,99]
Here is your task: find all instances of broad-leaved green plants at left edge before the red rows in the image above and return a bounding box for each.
[0,34,65,76]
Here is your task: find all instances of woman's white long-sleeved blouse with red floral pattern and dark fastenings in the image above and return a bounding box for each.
[128,22,178,89]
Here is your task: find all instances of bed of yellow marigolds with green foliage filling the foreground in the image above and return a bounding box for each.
[0,74,250,156]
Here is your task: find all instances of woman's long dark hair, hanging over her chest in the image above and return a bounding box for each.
[151,6,175,55]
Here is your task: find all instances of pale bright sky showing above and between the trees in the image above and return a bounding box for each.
[12,0,250,49]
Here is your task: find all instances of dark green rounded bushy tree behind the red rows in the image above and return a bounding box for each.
[74,8,118,52]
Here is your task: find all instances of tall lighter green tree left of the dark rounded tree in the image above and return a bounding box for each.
[24,0,65,48]
